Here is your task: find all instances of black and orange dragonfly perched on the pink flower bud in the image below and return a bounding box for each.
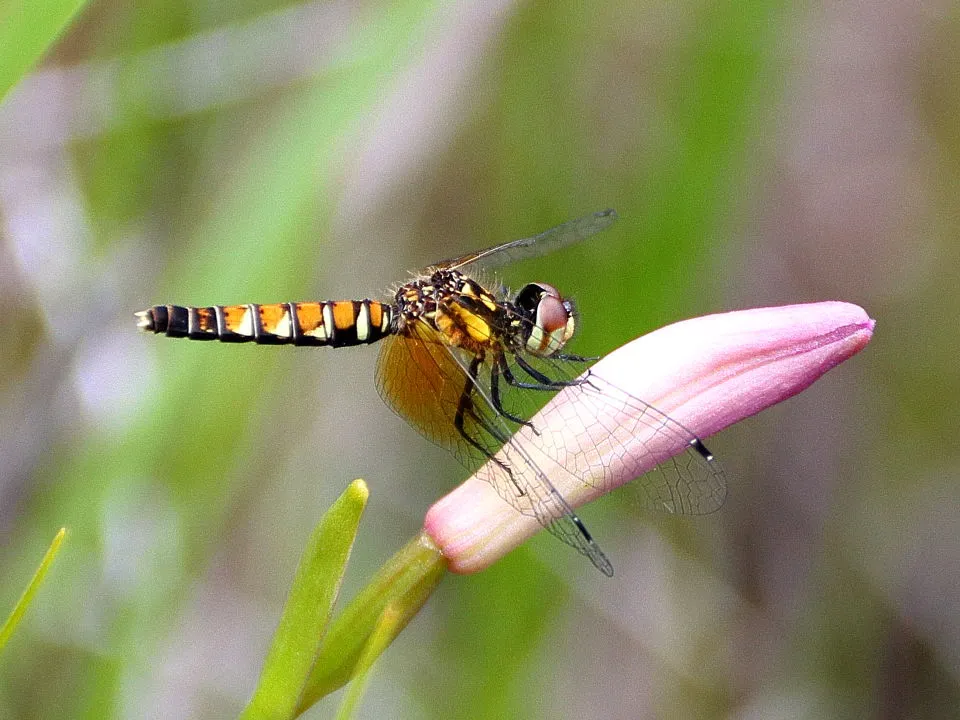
[136,210,726,576]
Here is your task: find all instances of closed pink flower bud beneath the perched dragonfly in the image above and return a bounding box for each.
[424,302,874,573]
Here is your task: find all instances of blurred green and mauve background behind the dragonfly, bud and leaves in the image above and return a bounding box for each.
[0,0,960,719]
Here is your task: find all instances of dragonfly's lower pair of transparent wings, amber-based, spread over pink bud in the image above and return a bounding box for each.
[377,300,726,575]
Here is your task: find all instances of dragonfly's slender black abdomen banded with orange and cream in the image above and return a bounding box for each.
[137,300,393,347]
